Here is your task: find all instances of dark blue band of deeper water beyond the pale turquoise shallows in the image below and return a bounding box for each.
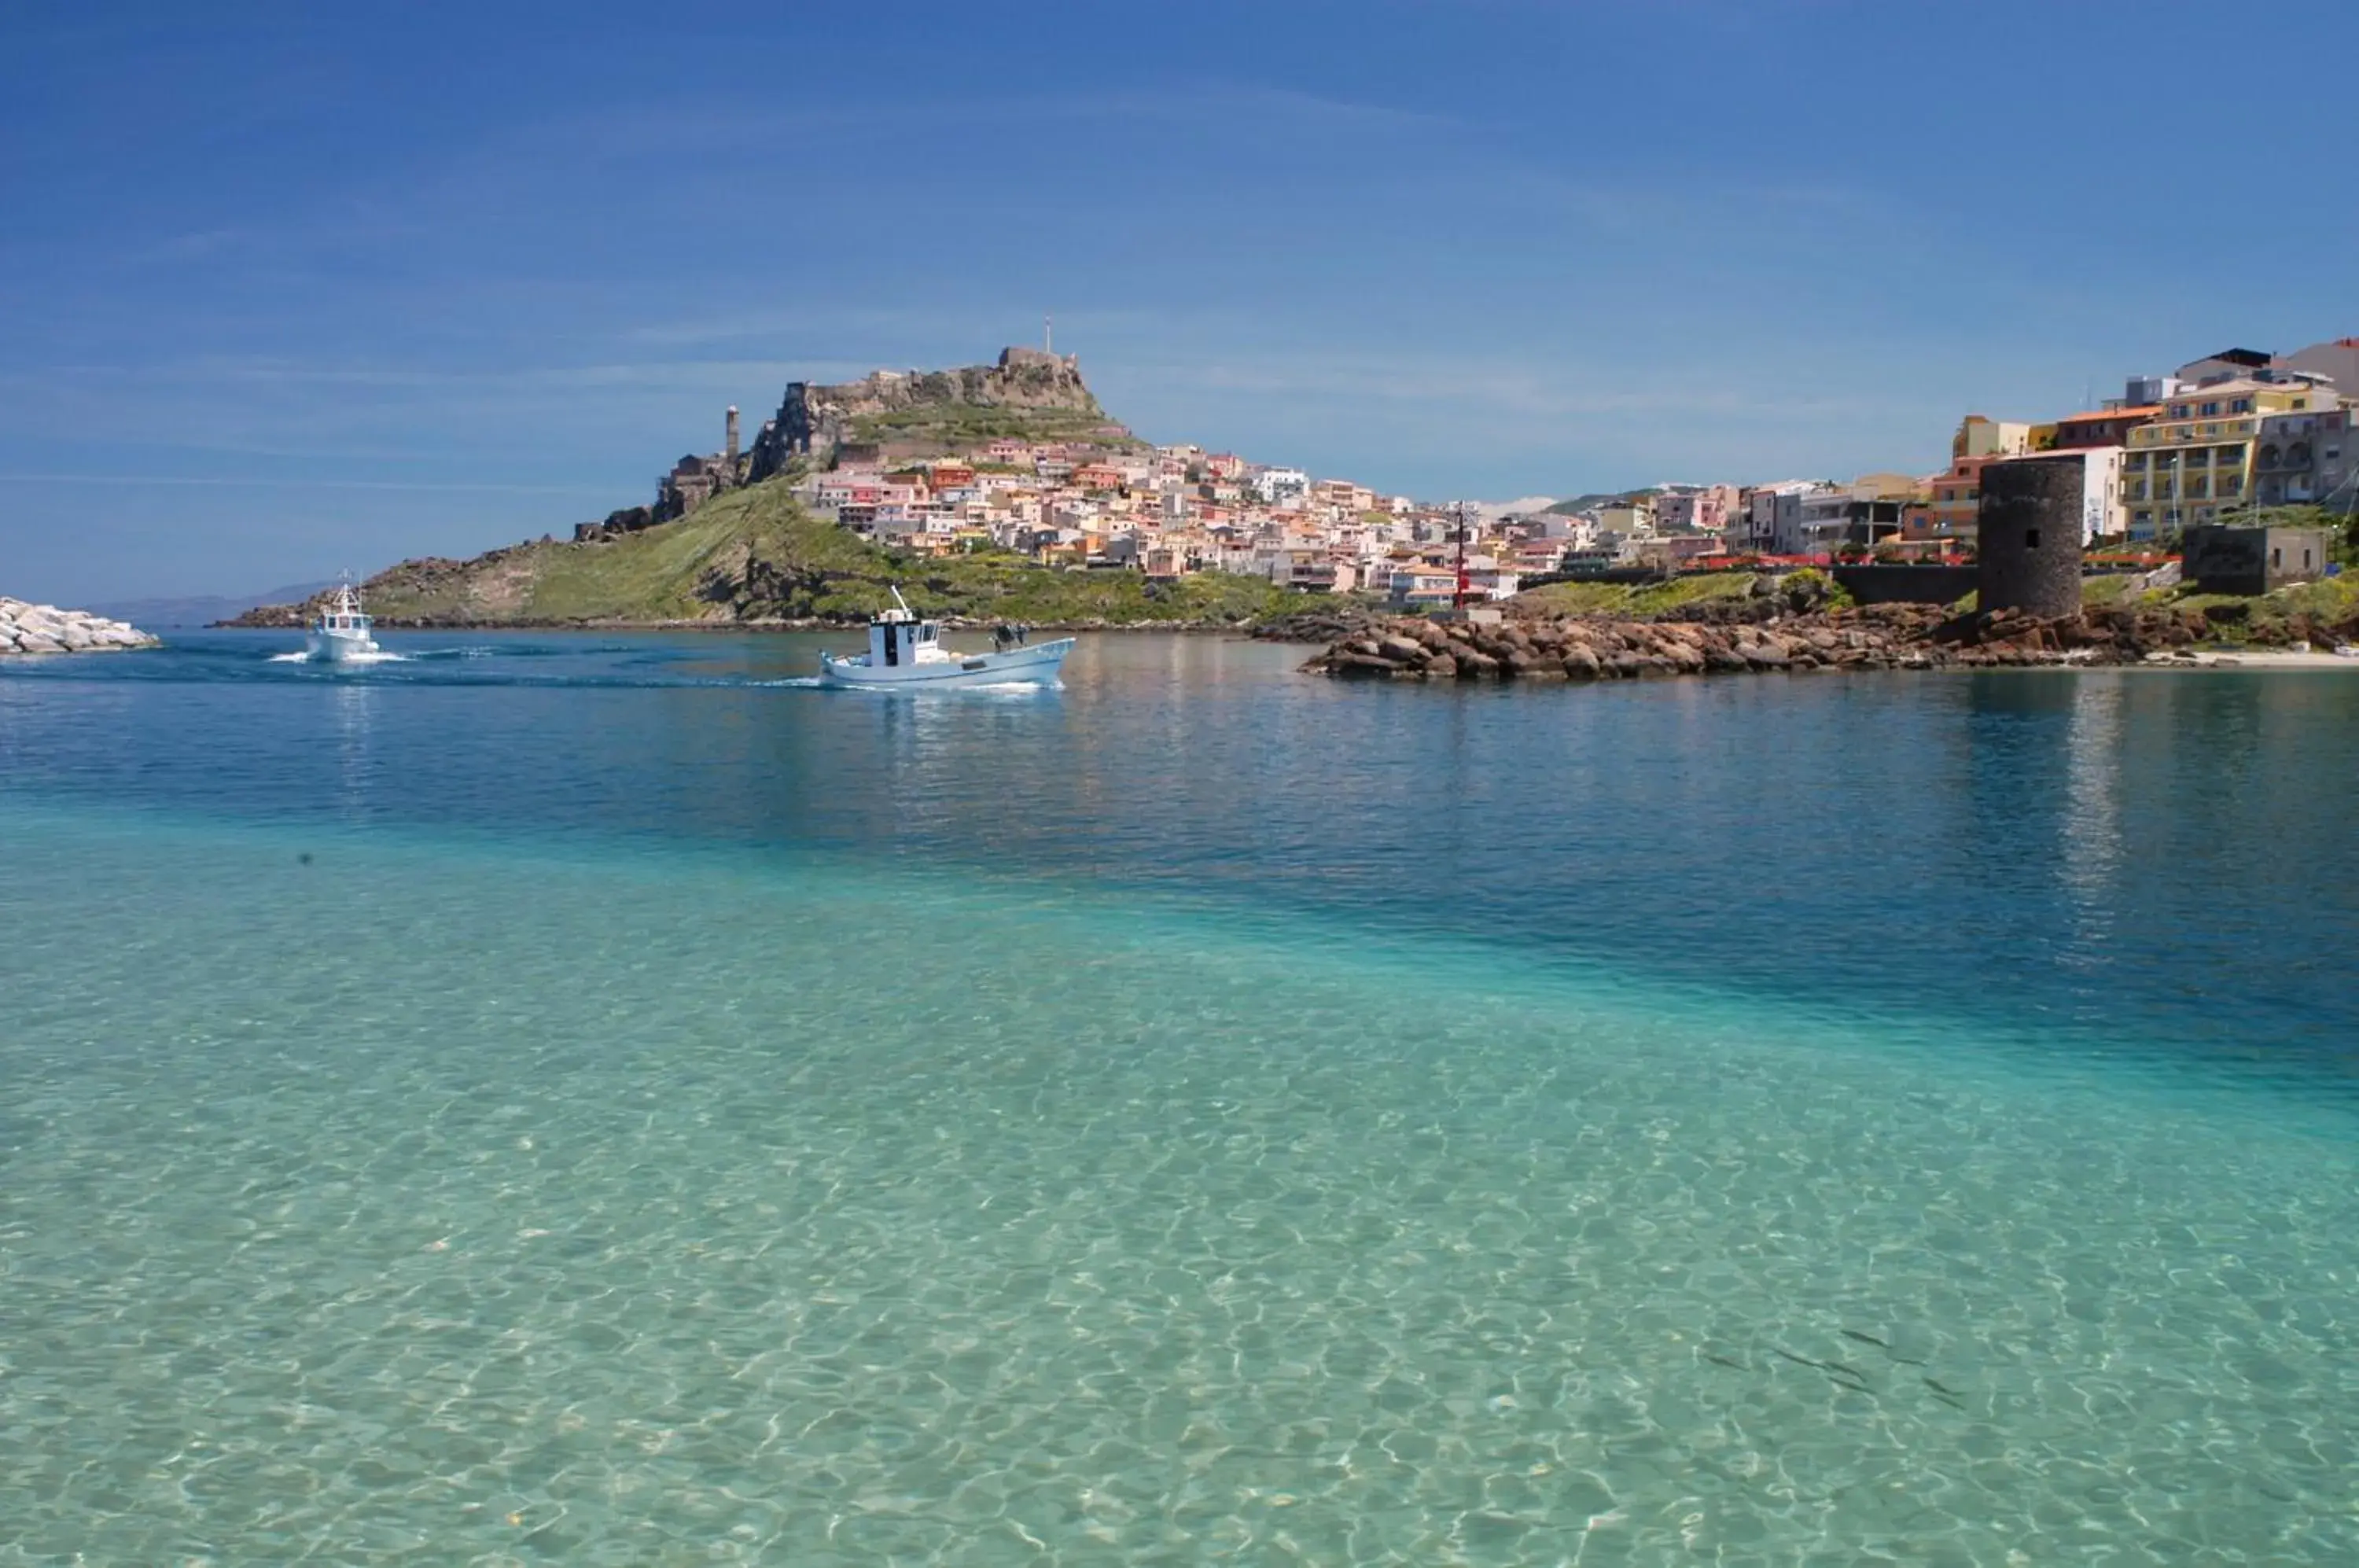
[13,635,2359,1082]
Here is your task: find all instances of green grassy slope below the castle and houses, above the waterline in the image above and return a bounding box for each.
[231,477,1300,628]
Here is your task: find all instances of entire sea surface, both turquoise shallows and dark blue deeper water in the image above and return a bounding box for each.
[0,637,2359,1563]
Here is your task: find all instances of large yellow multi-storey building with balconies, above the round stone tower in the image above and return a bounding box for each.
[2121,377,2338,540]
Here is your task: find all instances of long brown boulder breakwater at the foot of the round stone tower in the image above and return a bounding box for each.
[1305,604,2246,682]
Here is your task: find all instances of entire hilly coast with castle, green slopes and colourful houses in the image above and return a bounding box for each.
[225,337,2359,625]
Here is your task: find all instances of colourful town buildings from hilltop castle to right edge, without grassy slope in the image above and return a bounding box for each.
[604,337,2359,606]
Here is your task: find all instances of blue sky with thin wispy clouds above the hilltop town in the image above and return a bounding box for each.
[0,0,2359,602]
